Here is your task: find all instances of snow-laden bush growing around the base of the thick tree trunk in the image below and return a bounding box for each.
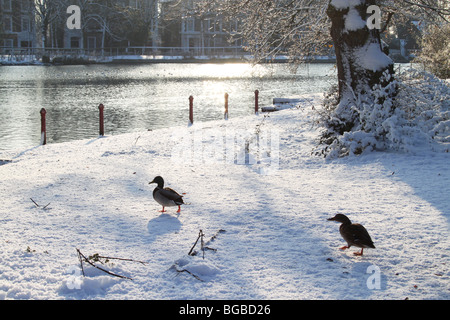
[316,69,450,158]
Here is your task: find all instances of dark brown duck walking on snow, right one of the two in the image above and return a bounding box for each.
[328,213,375,256]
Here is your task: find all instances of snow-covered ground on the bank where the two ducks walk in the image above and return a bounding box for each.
[0,95,450,299]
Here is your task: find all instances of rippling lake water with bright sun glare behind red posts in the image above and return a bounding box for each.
[0,63,337,150]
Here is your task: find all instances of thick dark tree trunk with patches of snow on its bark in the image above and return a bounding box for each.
[327,0,394,134]
